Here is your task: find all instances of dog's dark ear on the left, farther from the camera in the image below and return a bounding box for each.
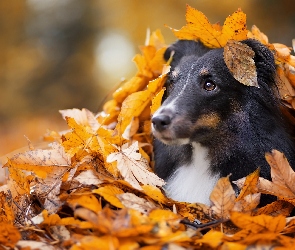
[164,40,210,68]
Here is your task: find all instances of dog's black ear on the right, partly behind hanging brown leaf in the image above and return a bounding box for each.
[242,39,276,86]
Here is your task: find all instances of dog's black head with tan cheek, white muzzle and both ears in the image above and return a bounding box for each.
[152,40,277,145]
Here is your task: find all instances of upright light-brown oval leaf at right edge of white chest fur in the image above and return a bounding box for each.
[210,176,236,219]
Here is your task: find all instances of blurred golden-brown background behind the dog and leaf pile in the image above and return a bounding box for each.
[0,0,295,156]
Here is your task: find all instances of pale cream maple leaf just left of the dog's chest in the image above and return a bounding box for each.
[107,141,165,190]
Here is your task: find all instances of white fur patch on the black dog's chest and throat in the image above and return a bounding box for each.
[164,143,219,205]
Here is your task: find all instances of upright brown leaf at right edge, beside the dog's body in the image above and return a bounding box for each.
[265,150,295,194]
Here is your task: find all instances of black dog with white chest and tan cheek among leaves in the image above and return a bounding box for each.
[152,39,295,204]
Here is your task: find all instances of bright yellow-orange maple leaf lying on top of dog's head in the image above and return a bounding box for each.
[172,5,248,48]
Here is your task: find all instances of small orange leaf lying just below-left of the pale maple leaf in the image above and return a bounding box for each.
[92,185,124,208]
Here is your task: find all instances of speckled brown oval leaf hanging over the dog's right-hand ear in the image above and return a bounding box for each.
[223,40,259,88]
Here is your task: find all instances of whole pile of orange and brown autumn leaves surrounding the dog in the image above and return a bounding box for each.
[0,6,295,250]
